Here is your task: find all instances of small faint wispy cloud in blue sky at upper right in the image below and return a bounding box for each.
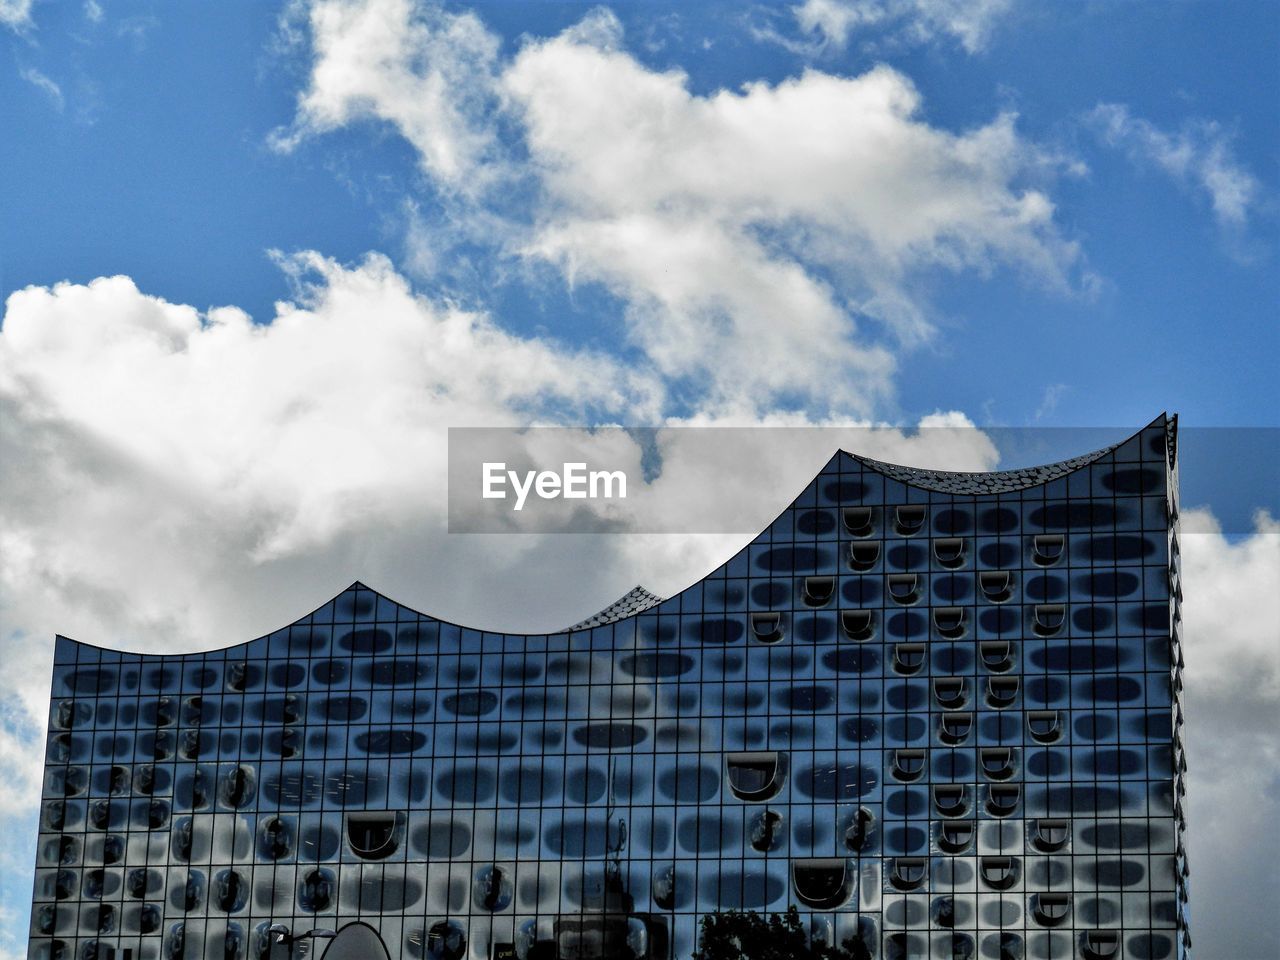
[1087,104,1260,229]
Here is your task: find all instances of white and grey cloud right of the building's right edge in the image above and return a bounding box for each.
[1181,509,1280,957]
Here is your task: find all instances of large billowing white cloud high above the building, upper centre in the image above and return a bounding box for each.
[280,0,1079,417]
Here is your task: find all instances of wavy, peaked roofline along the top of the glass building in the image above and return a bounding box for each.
[55,412,1178,663]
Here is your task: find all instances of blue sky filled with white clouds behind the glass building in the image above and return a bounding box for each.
[0,0,1280,960]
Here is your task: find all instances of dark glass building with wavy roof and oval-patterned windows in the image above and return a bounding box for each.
[29,416,1190,960]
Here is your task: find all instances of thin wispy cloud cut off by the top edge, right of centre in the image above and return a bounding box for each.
[792,0,1012,54]
